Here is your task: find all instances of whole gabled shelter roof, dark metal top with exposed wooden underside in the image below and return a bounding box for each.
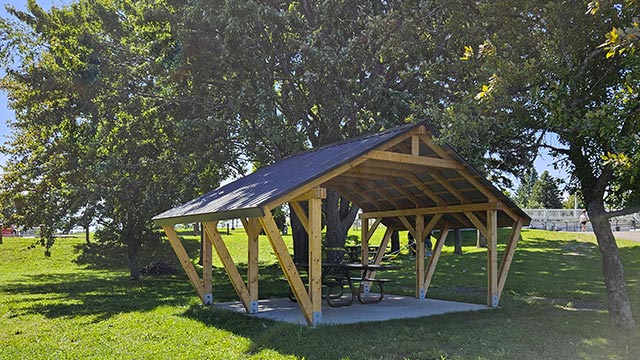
[153,123,530,228]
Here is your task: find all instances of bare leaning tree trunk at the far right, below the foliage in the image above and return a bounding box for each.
[587,204,636,330]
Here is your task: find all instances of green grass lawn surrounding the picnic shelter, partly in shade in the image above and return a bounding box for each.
[0,230,640,359]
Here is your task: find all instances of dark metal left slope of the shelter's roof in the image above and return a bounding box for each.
[153,124,420,224]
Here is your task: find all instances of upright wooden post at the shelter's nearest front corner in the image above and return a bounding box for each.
[309,198,322,325]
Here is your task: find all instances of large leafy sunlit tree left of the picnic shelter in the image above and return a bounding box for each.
[0,0,237,278]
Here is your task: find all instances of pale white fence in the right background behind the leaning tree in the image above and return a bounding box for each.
[524,209,640,231]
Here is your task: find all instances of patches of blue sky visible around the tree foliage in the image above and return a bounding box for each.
[0,0,567,191]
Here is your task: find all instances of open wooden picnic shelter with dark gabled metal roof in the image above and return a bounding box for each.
[153,123,531,326]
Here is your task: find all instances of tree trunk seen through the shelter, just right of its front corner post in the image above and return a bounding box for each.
[323,189,358,263]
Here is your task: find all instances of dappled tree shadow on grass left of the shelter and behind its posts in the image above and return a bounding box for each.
[0,265,287,322]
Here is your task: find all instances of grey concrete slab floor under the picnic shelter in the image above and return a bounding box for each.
[214,294,491,325]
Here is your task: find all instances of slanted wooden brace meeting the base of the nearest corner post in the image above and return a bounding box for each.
[260,208,315,325]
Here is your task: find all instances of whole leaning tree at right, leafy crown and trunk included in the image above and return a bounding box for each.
[450,2,640,329]
